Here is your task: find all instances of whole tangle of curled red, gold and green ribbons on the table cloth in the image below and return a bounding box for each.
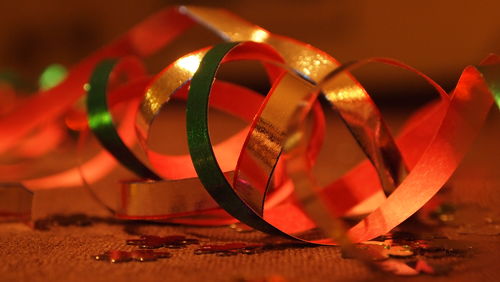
[0,4,500,253]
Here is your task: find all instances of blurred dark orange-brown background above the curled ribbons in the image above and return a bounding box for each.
[0,0,500,103]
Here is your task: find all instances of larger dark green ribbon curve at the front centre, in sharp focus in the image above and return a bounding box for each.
[186,42,291,238]
